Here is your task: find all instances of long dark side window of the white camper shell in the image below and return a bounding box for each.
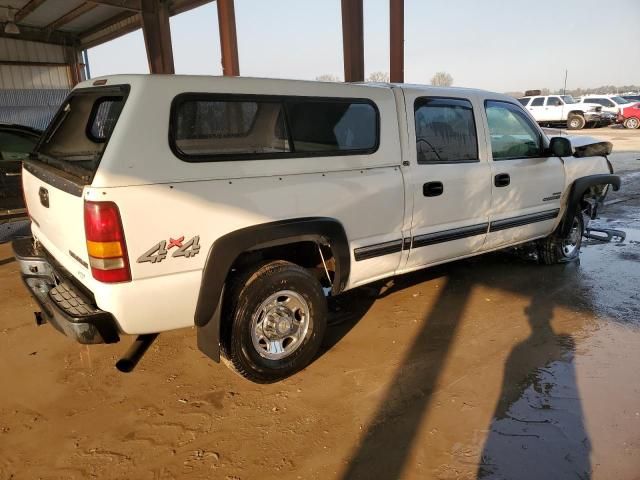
[169,93,380,162]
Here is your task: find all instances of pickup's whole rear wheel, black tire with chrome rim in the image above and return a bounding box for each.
[222,260,327,383]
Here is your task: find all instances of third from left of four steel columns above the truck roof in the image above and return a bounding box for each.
[342,0,364,82]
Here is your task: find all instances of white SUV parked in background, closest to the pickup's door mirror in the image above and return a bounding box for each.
[518,95,607,130]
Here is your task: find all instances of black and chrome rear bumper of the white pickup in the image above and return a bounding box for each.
[12,238,120,344]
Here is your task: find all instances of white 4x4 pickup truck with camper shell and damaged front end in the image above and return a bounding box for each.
[13,75,620,382]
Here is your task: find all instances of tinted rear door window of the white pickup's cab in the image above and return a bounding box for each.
[414,97,478,164]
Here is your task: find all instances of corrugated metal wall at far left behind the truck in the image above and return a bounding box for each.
[0,38,72,128]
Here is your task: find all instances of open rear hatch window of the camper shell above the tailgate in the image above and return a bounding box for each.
[36,87,126,181]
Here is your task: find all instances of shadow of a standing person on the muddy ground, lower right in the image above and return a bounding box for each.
[477,291,591,480]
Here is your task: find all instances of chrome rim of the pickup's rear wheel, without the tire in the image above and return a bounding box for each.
[251,290,311,360]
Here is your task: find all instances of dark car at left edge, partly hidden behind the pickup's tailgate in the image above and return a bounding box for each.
[0,123,42,221]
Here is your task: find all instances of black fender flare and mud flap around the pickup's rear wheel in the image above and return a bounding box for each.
[194,217,351,361]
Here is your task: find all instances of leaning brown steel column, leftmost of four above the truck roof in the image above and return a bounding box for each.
[140,0,175,73]
